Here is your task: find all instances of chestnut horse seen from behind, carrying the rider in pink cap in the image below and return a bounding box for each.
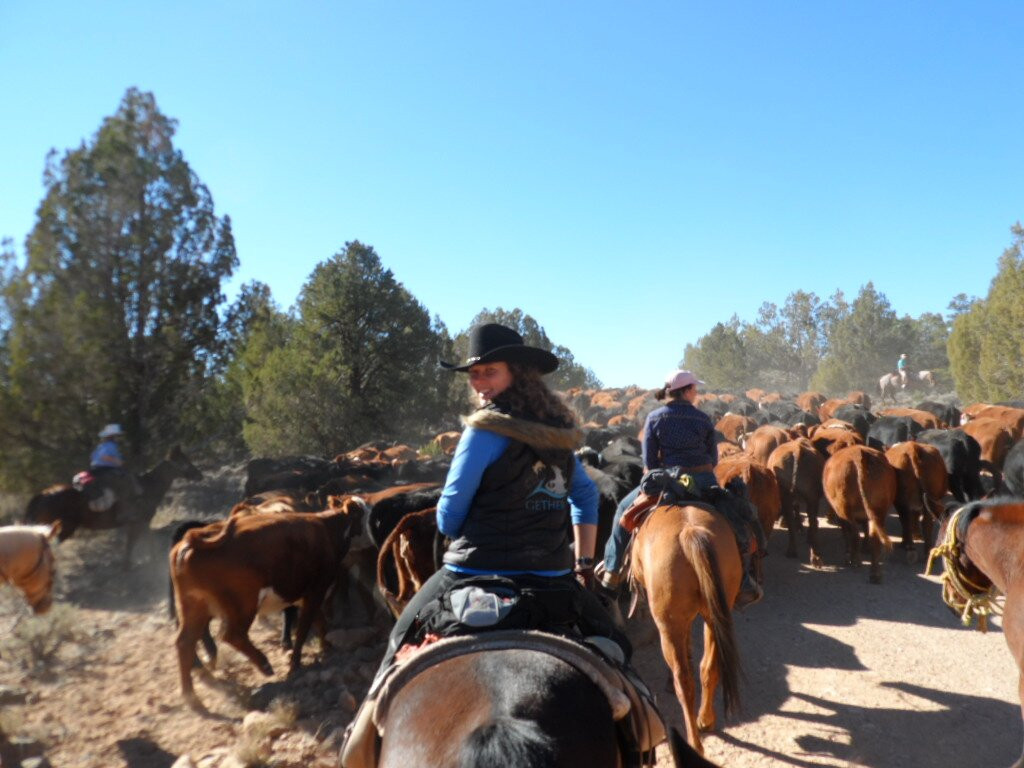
[631,505,742,755]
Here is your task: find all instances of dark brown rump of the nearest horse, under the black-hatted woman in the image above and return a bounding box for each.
[377,648,716,768]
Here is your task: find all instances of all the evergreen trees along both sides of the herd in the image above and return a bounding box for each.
[0,88,1024,489]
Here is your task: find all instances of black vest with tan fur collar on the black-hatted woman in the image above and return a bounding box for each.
[444,411,580,571]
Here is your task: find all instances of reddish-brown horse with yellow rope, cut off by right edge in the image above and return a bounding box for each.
[926,500,1024,768]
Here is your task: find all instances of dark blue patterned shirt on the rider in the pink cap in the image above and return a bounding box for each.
[643,400,718,469]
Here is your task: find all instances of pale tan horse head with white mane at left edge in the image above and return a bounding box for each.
[0,521,60,613]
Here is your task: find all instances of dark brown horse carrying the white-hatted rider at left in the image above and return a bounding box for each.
[25,445,203,568]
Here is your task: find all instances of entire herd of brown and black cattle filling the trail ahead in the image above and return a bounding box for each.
[6,388,1024,765]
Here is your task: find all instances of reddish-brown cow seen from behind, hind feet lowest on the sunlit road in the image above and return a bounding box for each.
[821,445,896,584]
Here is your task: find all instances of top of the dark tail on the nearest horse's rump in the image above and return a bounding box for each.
[459,717,558,768]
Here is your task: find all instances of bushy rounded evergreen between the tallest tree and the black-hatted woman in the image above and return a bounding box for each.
[243,242,449,455]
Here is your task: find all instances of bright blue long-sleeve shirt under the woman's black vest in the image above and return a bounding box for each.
[437,427,599,577]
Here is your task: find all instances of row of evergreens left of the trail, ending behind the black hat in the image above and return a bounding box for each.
[0,88,600,489]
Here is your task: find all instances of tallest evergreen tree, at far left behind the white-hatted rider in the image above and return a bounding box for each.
[0,88,238,484]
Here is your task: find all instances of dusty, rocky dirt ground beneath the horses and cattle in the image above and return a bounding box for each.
[0,466,1021,768]
